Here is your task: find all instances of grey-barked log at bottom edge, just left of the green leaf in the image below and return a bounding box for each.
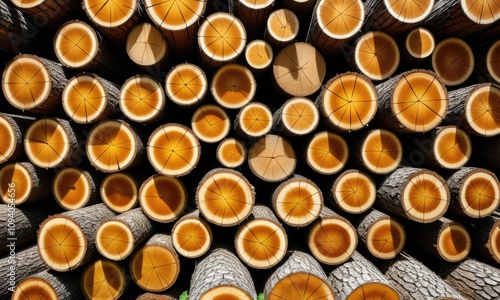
[189,248,257,300]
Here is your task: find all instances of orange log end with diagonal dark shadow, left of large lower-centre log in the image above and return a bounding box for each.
[139,174,188,223]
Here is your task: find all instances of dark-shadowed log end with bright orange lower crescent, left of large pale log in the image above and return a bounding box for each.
[210,64,257,109]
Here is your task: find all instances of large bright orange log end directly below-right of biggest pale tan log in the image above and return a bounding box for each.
[317,72,378,132]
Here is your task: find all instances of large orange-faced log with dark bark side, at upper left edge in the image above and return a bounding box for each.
[2,54,68,114]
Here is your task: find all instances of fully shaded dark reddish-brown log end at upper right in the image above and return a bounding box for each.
[432,37,474,86]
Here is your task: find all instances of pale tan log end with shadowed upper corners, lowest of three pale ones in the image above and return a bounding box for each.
[248,134,297,182]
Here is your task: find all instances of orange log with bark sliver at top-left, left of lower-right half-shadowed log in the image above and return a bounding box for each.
[307,206,358,265]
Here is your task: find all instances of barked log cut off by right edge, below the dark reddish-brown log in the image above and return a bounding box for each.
[445,83,500,137]
